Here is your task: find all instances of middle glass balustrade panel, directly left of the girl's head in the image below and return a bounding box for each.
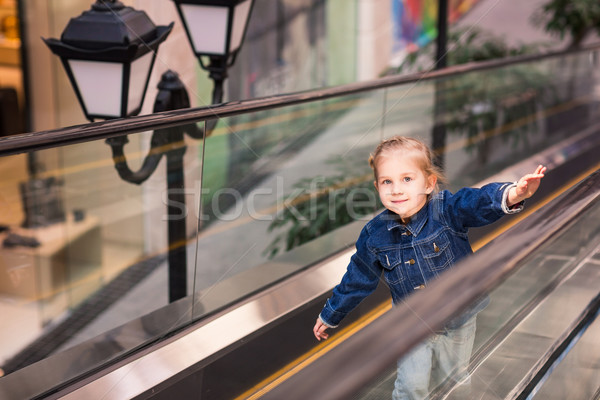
[194,90,385,317]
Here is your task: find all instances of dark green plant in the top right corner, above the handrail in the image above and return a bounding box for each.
[532,0,600,48]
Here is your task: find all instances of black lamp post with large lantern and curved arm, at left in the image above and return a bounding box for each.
[44,0,196,302]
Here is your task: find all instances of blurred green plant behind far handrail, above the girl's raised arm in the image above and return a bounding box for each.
[399,27,556,166]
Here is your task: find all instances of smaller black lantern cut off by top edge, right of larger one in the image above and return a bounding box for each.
[173,0,254,104]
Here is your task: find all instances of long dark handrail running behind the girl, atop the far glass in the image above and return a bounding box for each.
[0,43,600,156]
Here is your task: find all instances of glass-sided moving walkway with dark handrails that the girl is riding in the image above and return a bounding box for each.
[0,48,600,400]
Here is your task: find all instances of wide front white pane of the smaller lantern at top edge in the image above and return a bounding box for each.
[181,4,229,54]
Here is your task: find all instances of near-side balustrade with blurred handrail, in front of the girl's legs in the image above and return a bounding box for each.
[261,172,600,399]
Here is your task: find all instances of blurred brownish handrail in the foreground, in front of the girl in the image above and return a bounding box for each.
[261,171,600,400]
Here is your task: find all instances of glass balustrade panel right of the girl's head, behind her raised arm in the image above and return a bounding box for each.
[384,48,600,190]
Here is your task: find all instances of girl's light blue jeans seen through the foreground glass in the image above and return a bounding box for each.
[392,316,476,400]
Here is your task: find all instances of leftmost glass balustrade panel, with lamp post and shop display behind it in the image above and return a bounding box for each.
[0,125,202,380]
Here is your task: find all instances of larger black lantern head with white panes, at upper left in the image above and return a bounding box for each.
[43,0,173,121]
